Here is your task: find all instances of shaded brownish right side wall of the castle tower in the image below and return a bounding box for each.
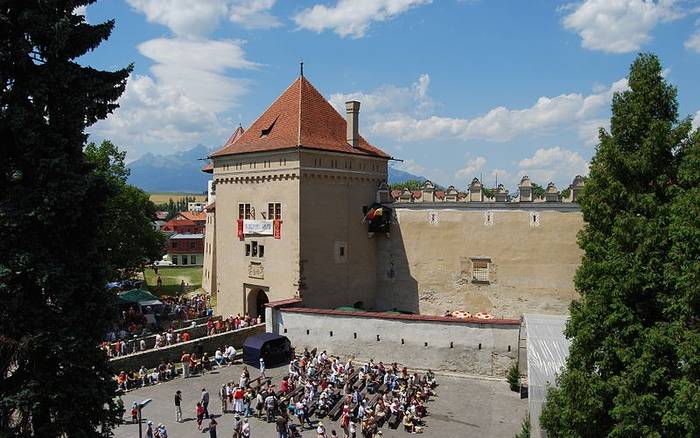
[300,151,387,308]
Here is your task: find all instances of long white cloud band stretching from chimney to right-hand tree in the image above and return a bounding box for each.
[371,79,627,142]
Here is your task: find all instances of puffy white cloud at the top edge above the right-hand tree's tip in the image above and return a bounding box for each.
[564,0,684,53]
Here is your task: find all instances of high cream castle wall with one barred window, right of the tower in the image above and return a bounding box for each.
[377,204,583,318]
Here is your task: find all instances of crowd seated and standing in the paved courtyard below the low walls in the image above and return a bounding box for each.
[118,346,437,438]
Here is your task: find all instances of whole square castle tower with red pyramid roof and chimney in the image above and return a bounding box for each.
[205,76,390,316]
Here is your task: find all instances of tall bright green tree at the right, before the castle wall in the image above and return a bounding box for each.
[540,54,700,437]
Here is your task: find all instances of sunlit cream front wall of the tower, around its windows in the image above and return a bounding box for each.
[214,151,299,315]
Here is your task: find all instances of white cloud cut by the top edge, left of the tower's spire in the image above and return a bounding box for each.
[127,0,281,37]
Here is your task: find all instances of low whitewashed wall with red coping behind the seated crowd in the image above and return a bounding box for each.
[268,308,520,378]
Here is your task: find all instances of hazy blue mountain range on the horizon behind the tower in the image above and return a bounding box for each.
[128,144,425,193]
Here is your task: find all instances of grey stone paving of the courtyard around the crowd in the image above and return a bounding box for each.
[115,365,527,438]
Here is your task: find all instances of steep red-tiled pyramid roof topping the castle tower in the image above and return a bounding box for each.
[211,76,390,158]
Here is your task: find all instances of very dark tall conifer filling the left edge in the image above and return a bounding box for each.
[0,0,131,438]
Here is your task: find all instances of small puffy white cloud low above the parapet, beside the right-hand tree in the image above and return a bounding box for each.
[518,146,588,188]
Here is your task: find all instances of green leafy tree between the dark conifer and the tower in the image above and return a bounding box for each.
[85,140,165,280]
